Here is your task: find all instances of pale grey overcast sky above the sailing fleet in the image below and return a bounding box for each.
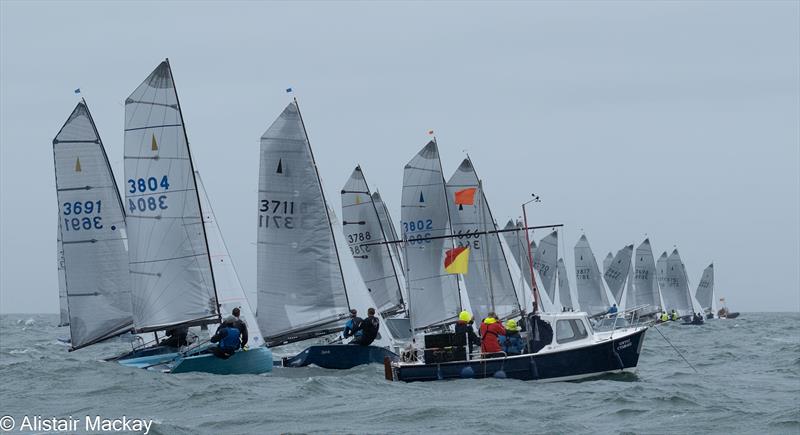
[0,0,800,313]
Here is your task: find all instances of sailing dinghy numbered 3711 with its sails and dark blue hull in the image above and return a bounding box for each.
[257,100,397,369]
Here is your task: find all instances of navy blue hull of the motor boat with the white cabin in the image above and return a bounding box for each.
[387,328,646,382]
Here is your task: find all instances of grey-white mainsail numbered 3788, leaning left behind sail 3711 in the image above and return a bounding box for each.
[342,166,403,313]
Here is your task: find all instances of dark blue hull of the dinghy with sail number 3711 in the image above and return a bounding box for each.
[283,344,398,370]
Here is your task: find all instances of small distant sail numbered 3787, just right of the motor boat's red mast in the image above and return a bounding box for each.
[575,235,609,315]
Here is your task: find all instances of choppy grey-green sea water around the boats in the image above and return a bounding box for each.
[0,313,800,434]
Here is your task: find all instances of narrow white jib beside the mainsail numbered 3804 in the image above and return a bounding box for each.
[195,172,264,347]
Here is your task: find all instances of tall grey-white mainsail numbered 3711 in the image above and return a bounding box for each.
[257,102,349,342]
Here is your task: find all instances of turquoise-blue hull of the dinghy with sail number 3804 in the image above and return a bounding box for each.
[170,347,272,375]
